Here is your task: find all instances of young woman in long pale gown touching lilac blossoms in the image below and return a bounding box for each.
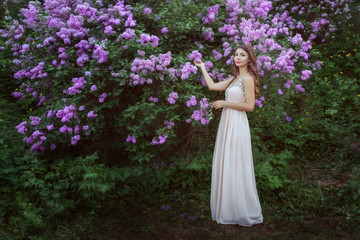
[195,45,263,227]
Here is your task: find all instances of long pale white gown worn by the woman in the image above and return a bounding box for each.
[210,78,263,227]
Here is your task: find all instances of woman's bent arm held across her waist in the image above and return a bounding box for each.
[212,76,255,112]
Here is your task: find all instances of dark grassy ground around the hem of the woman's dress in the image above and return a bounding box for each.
[39,157,360,240]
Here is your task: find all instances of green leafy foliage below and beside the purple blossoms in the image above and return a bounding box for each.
[0,1,360,239]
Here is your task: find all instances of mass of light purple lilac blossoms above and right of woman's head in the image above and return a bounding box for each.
[216,0,344,80]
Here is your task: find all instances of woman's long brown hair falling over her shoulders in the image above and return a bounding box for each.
[229,45,259,97]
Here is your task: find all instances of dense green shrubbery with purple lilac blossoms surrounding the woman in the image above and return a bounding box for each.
[0,0,360,239]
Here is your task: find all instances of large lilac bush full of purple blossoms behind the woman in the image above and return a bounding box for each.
[0,0,351,159]
